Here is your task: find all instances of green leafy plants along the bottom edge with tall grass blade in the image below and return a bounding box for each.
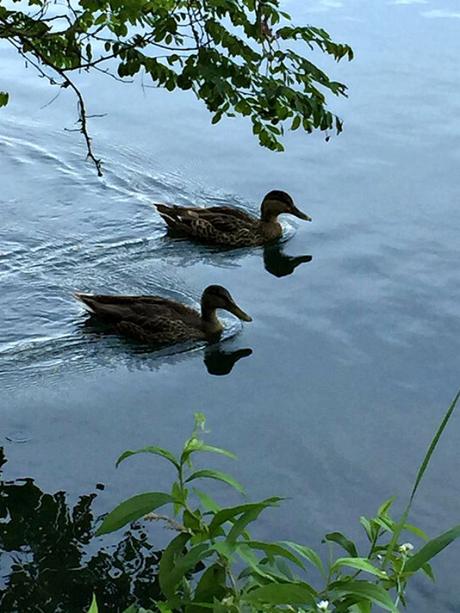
[92,392,460,613]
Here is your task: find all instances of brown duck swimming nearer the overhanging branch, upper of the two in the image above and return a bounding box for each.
[155,190,311,247]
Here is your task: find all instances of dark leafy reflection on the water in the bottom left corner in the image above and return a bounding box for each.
[0,448,164,613]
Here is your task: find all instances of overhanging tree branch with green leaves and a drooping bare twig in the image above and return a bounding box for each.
[0,0,353,172]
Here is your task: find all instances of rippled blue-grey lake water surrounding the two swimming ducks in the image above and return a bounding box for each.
[0,0,460,613]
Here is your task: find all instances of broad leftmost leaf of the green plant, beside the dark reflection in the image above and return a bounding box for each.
[96,492,174,536]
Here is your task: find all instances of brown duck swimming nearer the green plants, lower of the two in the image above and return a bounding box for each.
[74,285,252,345]
